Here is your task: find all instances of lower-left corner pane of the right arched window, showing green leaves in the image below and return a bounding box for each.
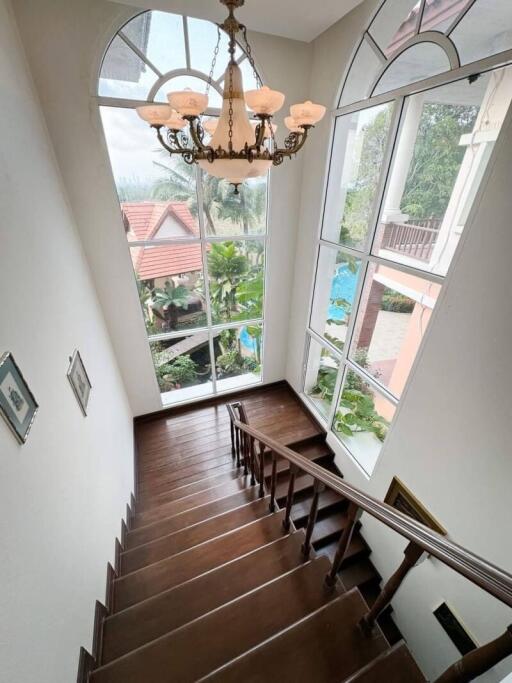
[304,338,339,418]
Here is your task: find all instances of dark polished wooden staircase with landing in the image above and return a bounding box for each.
[79,387,424,683]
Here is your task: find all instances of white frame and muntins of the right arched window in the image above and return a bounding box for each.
[300,0,512,478]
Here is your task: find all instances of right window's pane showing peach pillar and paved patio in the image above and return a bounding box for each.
[350,264,441,397]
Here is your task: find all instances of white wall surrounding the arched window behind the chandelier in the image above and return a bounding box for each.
[16,0,311,414]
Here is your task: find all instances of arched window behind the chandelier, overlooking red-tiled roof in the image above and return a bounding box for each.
[98,11,267,404]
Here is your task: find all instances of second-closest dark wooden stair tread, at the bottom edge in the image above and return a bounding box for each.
[202,589,387,683]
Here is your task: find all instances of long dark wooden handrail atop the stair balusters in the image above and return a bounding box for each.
[227,403,512,607]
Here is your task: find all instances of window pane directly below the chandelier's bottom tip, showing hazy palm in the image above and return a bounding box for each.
[201,171,267,237]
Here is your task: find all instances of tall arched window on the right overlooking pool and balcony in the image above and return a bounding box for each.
[304,0,512,475]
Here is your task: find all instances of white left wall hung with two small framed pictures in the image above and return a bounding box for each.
[0,0,133,683]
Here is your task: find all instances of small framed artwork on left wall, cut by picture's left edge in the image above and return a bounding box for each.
[0,351,39,443]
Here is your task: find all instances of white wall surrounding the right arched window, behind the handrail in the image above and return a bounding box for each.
[287,0,512,682]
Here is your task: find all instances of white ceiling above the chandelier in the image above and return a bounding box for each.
[111,0,362,42]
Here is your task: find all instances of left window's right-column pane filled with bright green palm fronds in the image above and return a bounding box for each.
[208,241,265,325]
